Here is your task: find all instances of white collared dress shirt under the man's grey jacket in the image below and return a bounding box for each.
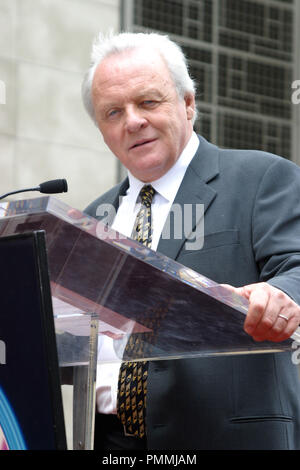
[96,132,199,414]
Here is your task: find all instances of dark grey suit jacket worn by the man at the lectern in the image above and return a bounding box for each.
[86,137,300,450]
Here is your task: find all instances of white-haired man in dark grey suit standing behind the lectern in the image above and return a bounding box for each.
[82,33,300,450]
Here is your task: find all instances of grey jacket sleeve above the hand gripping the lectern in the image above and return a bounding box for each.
[252,158,300,304]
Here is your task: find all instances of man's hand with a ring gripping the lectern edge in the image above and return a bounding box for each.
[224,282,300,342]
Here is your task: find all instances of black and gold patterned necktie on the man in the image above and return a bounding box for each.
[117,185,155,438]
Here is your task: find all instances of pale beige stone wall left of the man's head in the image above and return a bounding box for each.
[0,0,119,209]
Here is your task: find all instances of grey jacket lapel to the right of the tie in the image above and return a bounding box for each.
[157,136,219,259]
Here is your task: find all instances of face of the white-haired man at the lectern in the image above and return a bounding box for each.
[92,49,195,182]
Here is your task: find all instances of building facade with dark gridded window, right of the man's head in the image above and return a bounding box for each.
[123,0,300,163]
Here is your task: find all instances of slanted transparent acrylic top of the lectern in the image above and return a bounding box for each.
[0,197,299,361]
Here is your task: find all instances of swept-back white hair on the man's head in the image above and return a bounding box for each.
[82,33,196,124]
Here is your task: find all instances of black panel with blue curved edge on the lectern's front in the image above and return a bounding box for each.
[0,232,66,450]
